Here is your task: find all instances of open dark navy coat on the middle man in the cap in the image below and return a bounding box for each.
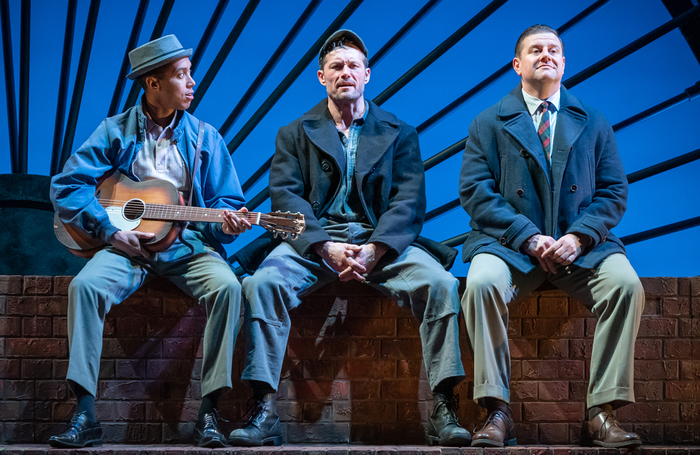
[235,99,456,273]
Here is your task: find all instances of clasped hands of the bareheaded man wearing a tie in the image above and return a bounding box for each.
[522,234,588,273]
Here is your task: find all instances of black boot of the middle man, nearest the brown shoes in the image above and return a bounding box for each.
[426,393,472,447]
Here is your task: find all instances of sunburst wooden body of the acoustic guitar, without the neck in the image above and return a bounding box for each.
[54,172,184,258]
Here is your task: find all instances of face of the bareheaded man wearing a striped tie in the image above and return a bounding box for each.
[513,33,565,86]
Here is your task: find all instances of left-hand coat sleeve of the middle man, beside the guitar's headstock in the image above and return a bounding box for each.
[269,126,331,256]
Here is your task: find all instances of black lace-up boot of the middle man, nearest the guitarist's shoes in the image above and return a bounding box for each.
[228,393,282,447]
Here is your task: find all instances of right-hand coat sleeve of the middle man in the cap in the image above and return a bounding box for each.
[368,124,426,254]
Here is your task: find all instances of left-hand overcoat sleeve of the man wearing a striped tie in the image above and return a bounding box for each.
[459,113,540,252]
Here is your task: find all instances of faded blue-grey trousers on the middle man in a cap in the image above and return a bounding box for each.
[241,243,464,390]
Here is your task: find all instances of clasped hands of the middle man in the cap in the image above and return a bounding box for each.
[314,241,387,281]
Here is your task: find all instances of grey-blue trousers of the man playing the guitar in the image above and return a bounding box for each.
[66,231,241,395]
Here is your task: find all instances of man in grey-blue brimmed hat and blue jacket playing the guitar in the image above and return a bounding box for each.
[49,35,250,447]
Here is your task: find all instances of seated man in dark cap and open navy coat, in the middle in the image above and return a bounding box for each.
[229,30,470,446]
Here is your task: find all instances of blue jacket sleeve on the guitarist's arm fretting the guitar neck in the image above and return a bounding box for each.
[199,126,245,243]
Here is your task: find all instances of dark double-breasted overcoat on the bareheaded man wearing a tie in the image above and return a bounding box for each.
[459,85,627,273]
